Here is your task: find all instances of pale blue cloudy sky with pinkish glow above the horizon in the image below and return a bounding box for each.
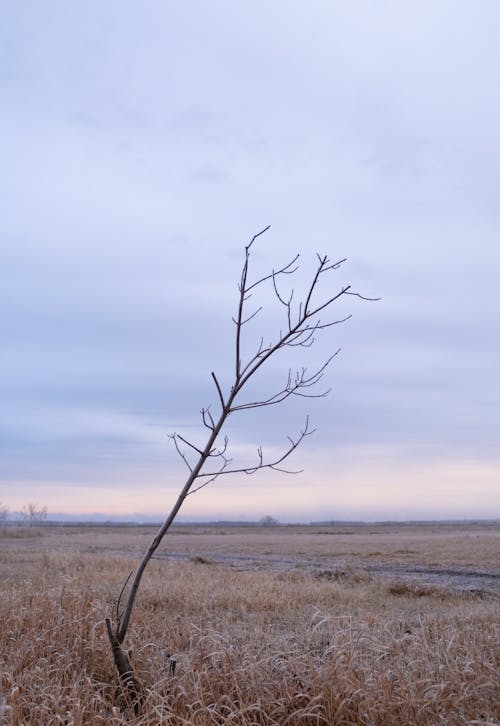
[0,0,500,521]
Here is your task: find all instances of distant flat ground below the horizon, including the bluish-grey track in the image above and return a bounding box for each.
[2,523,500,592]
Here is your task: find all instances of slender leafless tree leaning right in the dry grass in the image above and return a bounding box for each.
[106,227,375,710]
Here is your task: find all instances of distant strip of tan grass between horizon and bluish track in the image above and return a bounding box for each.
[0,523,500,568]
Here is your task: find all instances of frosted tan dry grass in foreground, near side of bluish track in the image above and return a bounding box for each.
[0,532,500,726]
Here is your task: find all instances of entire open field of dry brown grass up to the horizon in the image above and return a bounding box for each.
[0,523,500,726]
